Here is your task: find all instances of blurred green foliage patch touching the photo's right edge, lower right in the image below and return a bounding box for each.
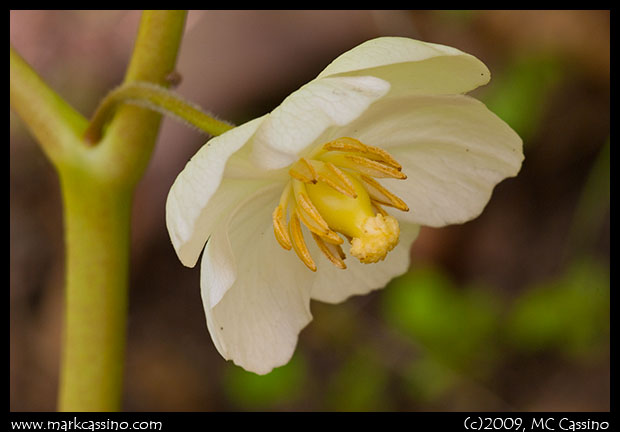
[507,259,610,356]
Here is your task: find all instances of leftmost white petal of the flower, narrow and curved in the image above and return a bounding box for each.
[166,117,264,267]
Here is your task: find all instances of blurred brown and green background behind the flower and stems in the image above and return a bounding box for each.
[9,10,610,411]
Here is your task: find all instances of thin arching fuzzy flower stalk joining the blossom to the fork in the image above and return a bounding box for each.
[84,82,233,144]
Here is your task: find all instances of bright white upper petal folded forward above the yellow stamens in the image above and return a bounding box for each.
[252,77,389,169]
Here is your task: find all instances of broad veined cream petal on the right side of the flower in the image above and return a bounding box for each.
[333,95,523,227]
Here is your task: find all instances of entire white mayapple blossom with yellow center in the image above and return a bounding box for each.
[166,37,523,374]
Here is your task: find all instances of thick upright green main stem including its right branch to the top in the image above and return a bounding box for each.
[55,11,186,411]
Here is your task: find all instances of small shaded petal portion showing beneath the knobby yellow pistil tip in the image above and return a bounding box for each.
[312,221,420,303]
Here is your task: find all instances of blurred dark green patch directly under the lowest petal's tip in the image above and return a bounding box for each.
[224,353,307,410]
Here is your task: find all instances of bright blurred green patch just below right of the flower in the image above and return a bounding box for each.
[383,267,498,367]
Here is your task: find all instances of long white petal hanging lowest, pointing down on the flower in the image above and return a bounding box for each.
[201,187,314,374]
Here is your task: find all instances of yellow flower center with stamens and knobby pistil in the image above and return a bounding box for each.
[273,137,409,271]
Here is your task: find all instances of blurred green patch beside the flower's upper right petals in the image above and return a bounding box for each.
[482,54,563,145]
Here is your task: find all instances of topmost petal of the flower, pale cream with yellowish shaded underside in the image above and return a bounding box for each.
[318,37,491,95]
